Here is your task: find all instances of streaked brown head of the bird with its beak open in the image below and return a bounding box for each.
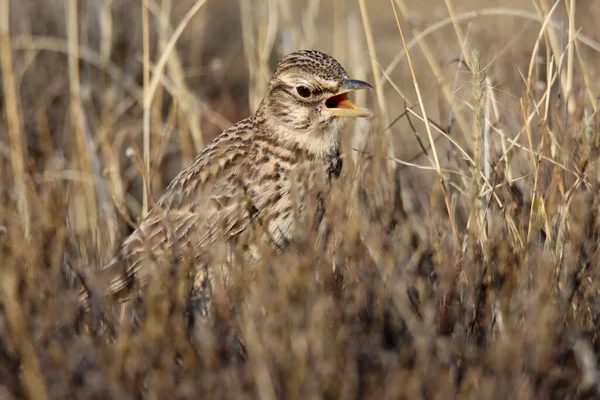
[261,50,372,157]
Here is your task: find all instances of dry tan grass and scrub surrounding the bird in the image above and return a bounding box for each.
[0,0,600,399]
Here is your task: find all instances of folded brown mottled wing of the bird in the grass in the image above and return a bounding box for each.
[96,130,253,299]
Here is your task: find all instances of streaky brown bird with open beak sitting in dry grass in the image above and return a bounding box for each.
[82,50,374,310]
